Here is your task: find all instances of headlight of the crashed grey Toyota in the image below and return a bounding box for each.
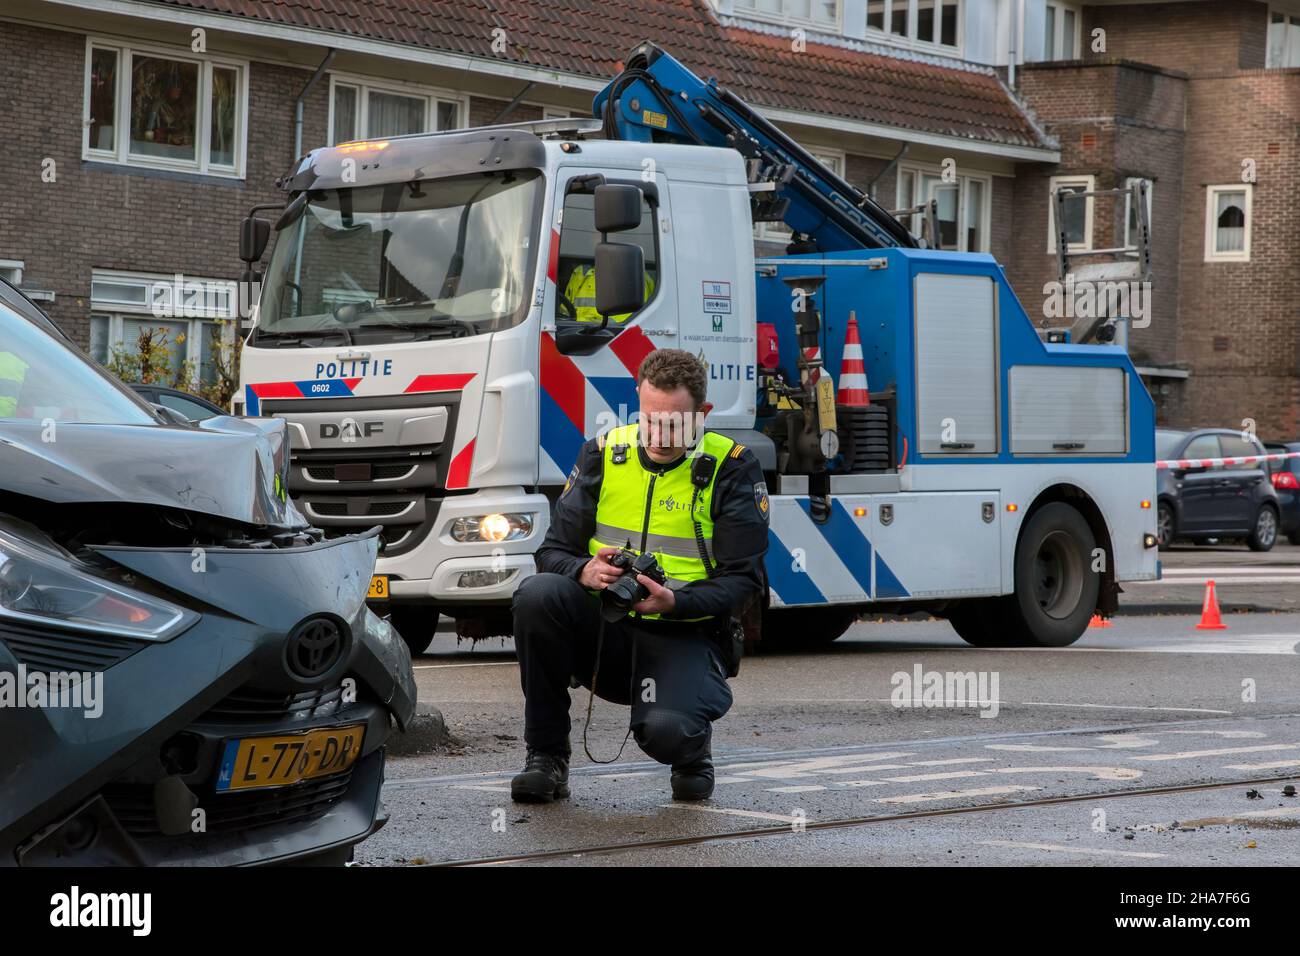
[0,537,199,641]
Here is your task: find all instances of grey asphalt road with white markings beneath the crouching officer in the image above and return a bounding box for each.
[356,606,1300,866]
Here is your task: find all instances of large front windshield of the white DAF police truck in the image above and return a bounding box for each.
[255,170,541,345]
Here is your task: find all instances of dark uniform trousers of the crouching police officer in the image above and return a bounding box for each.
[512,574,732,766]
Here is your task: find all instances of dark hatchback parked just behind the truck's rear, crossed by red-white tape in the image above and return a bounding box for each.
[1156,428,1281,551]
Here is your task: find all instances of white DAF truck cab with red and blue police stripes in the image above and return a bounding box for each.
[235,120,755,650]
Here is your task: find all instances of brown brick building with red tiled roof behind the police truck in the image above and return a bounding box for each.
[0,0,1300,438]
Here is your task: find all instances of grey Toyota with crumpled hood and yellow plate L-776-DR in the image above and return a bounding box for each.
[0,293,416,866]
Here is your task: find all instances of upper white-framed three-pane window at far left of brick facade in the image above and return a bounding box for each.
[82,39,248,177]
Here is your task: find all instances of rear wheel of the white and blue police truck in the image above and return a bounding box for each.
[1004,502,1101,648]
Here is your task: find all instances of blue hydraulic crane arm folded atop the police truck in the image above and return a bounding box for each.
[592,42,918,252]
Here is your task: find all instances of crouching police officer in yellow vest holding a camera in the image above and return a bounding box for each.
[511,349,768,803]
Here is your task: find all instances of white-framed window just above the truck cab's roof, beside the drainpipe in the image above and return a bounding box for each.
[329,77,465,146]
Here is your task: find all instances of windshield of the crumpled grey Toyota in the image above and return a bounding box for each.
[0,303,159,425]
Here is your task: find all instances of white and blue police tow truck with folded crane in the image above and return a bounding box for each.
[235,43,1157,650]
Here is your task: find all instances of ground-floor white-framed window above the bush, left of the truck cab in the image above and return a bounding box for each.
[90,269,238,389]
